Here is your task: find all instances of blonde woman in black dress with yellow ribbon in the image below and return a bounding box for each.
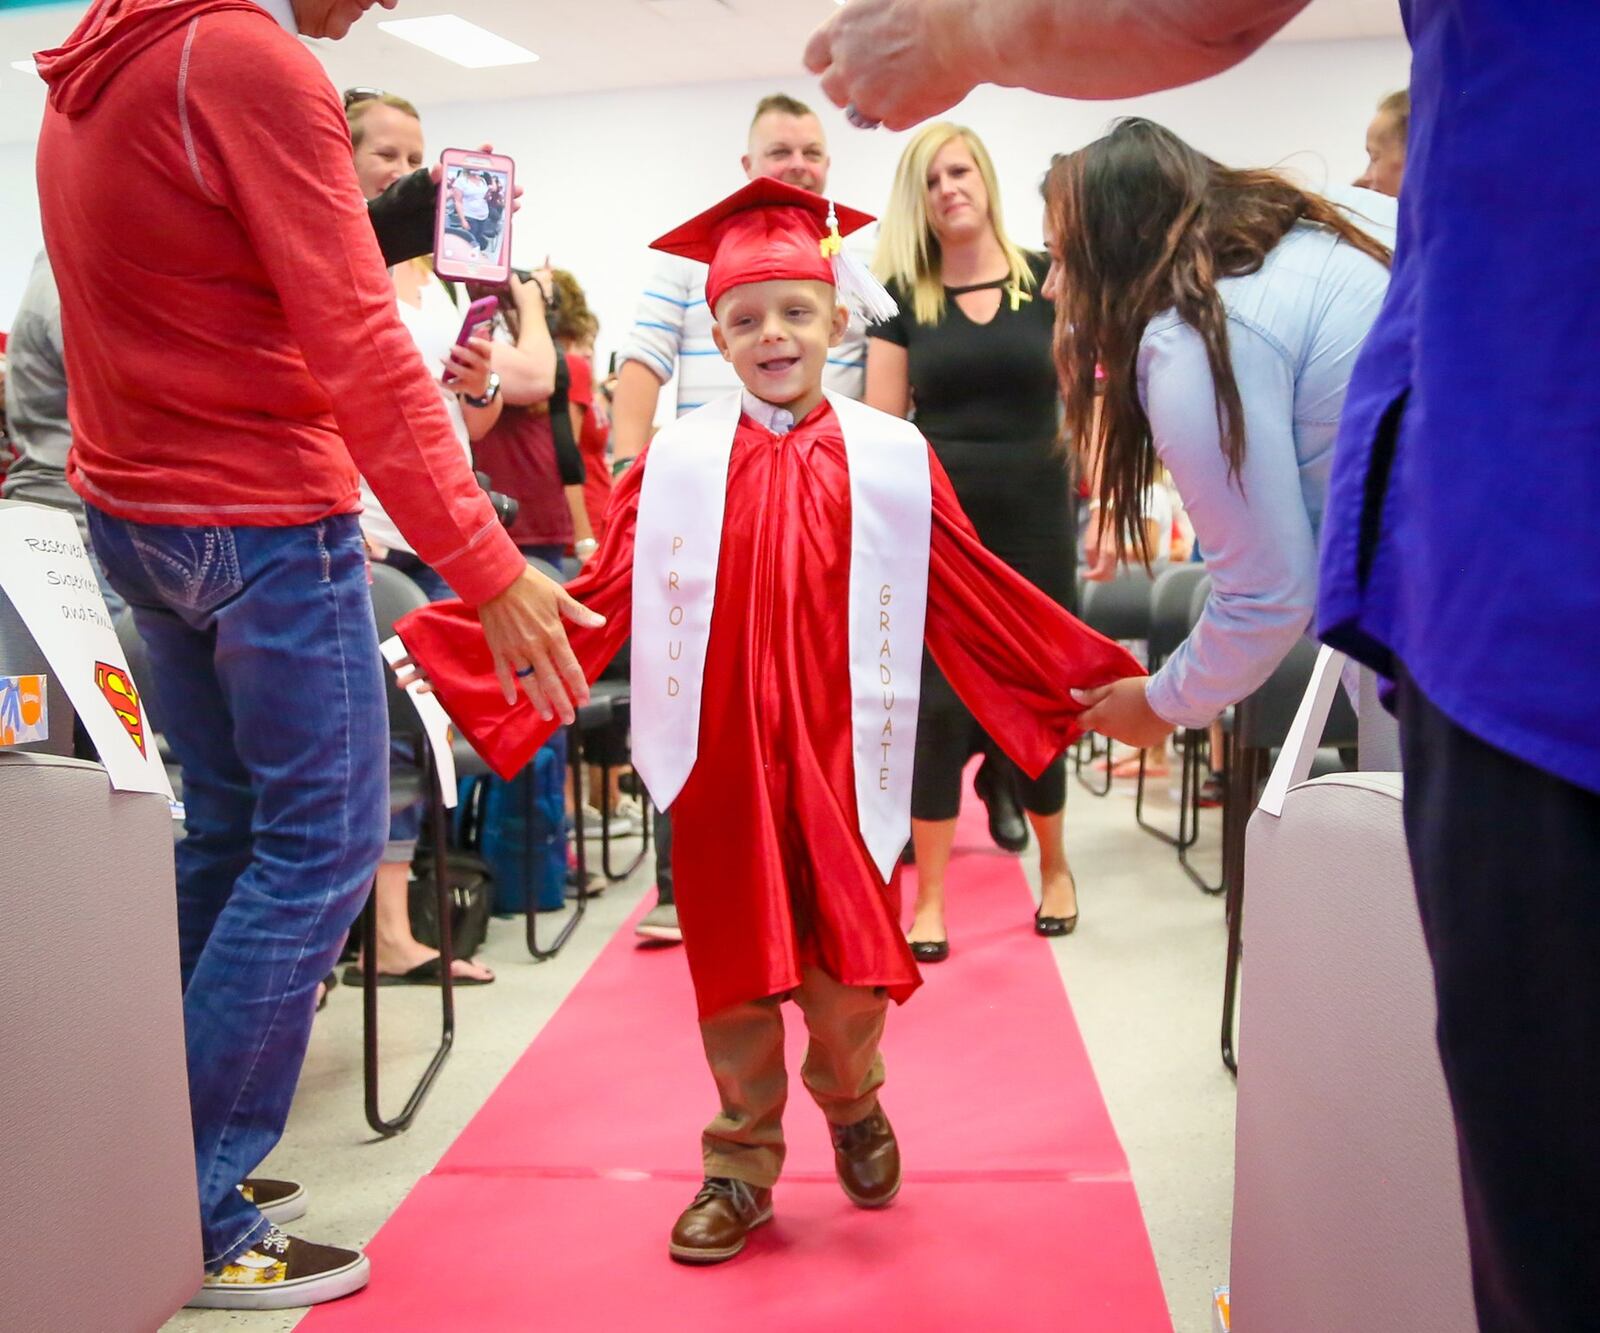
[866,123,1078,962]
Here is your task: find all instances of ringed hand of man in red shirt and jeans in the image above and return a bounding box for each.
[478,570,605,725]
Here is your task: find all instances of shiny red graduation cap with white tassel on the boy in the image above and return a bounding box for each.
[651,176,894,318]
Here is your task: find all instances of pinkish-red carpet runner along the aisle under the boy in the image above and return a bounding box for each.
[299,794,1171,1333]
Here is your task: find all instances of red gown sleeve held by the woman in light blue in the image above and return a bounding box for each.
[926,453,1144,778]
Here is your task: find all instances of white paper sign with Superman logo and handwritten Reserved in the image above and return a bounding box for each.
[0,504,173,800]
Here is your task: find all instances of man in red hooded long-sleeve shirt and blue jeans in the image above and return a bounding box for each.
[37,0,601,1309]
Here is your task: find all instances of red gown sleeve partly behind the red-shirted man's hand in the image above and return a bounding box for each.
[395,458,645,779]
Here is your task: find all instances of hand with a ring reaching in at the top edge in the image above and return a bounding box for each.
[805,0,998,130]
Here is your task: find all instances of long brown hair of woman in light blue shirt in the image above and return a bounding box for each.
[1043,118,1392,563]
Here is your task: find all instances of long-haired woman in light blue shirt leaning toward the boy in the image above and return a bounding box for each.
[1045,120,1394,746]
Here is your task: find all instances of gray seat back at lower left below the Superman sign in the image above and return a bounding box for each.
[0,751,202,1333]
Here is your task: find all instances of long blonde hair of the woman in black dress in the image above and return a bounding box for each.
[872,120,1034,323]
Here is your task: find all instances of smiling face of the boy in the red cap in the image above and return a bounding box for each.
[712,280,850,421]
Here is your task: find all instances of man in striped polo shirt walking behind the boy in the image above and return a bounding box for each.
[611,93,867,941]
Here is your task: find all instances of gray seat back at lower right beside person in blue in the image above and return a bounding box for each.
[1230,773,1477,1333]
